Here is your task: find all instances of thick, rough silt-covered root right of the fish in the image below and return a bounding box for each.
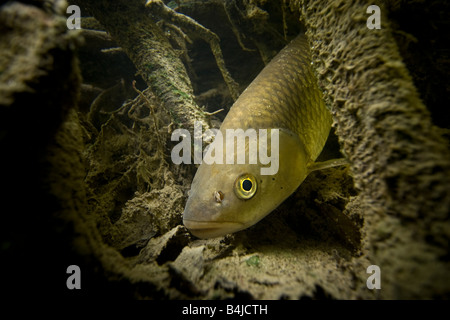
[290,0,450,299]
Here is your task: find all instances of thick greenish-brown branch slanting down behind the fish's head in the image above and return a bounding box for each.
[72,0,209,129]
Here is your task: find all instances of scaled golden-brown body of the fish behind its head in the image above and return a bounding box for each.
[221,35,332,161]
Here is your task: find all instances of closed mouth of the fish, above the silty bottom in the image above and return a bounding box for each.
[183,219,244,239]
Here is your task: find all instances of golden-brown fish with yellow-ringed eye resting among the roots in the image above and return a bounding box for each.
[183,34,339,239]
